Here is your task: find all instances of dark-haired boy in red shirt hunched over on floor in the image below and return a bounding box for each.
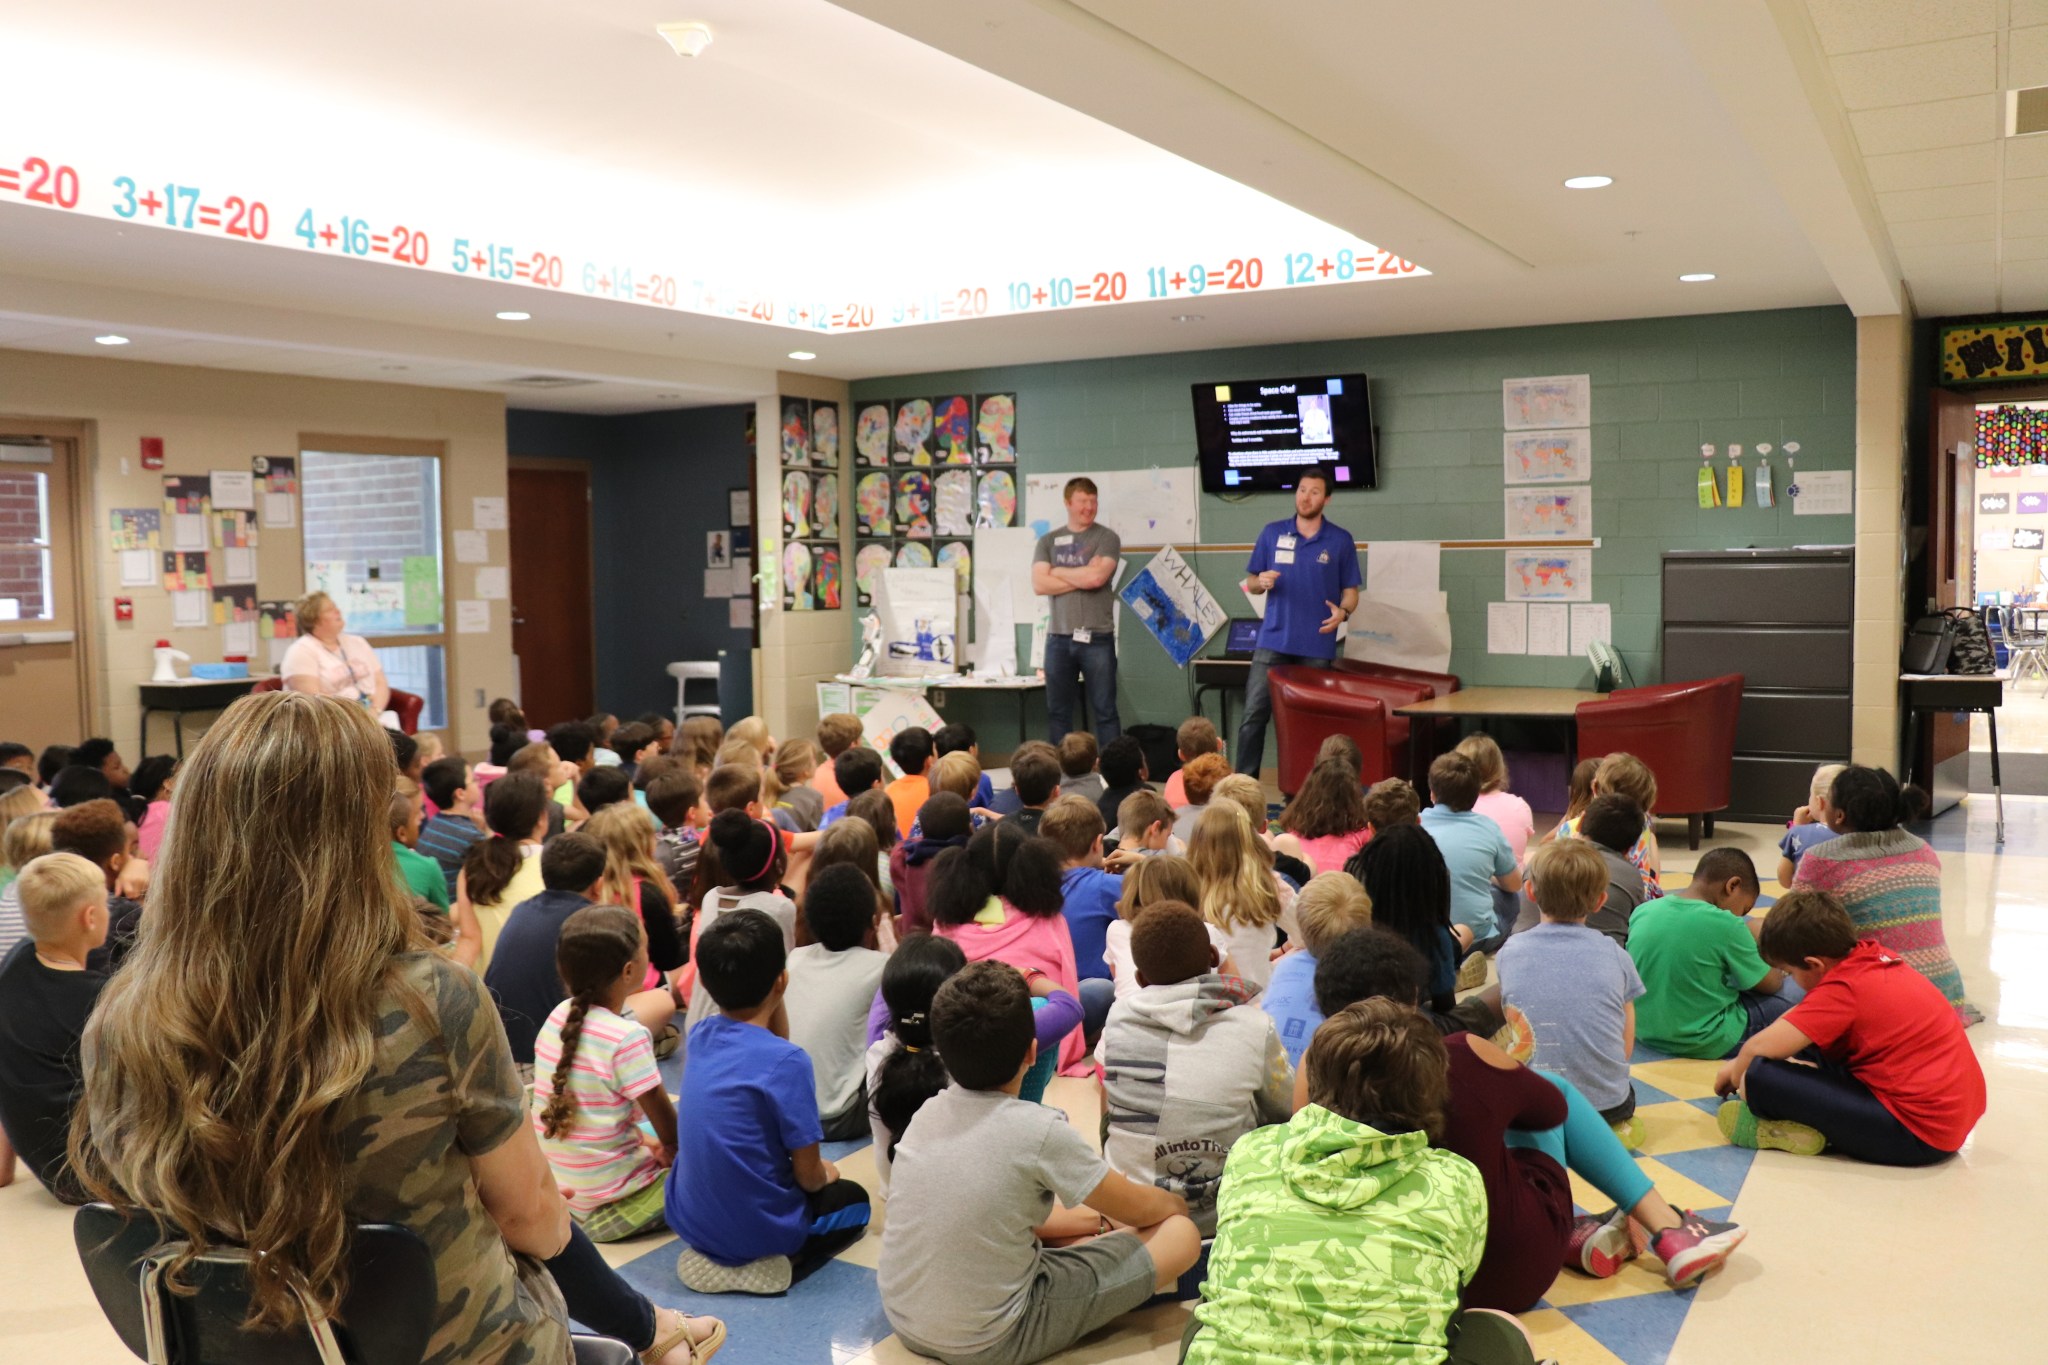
[1714,890,1985,1166]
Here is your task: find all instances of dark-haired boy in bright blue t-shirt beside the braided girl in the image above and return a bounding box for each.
[668,909,868,1293]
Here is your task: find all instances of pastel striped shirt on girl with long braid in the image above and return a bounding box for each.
[532,1001,664,1216]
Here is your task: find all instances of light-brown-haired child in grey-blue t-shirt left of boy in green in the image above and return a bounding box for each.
[1499,839,1642,1146]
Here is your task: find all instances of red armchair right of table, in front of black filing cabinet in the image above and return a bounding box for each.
[1577,673,1743,847]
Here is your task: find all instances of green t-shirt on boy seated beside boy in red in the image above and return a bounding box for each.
[1628,896,1772,1060]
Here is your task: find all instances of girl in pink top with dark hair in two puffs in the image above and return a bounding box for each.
[924,821,1090,1074]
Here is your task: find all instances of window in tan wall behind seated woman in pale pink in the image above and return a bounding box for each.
[299,450,449,731]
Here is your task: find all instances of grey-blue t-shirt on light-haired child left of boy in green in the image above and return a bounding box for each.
[1495,925,1642,1109]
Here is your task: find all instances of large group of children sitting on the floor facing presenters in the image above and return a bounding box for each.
[0,702,1985,1365]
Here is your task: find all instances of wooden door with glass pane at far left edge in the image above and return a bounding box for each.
[0,434,87,759]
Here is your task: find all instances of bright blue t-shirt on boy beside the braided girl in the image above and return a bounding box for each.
[666,1015,825,1265]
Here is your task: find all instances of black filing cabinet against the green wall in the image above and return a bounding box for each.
[1663,546,1855,823]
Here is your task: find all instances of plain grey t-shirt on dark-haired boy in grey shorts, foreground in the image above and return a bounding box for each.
[877,1085,1110,1355]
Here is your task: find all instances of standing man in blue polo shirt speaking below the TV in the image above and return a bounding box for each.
[1237,469,1360,778]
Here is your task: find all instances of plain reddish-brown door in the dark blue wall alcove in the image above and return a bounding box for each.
[506,460,598,729]
